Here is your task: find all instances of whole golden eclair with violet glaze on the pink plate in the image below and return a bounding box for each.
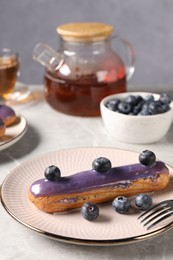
[28,156,170,213]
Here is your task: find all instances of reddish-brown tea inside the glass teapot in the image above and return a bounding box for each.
[45,70,126,116]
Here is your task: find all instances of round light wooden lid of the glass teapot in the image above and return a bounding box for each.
[57,22,113,42]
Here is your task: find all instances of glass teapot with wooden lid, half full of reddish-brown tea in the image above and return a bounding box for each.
[33,23,135,116]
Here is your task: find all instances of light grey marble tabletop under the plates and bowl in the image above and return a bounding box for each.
[0,85,173,260]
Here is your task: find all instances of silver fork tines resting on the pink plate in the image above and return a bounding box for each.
[138,200,173,230]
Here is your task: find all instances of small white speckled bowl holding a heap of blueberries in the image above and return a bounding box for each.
[100,92,173,144]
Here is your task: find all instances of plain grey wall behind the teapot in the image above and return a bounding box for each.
[0,0,173,93]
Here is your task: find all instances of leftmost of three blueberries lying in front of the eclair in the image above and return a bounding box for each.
[80,202,99,221]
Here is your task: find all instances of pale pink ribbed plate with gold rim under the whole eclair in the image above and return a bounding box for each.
[1,148,173,245]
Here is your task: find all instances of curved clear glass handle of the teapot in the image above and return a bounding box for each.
[111,35,136,80]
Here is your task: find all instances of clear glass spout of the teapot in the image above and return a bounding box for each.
[33,43,64,71]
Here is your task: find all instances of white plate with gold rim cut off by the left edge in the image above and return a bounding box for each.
[0,116,27,151]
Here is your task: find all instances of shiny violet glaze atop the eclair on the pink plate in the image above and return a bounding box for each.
[30,161,169,197]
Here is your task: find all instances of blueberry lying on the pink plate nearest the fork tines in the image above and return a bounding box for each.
[135,194,152,210]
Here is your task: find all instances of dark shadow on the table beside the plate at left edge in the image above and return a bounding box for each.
[0,125,41,163]
